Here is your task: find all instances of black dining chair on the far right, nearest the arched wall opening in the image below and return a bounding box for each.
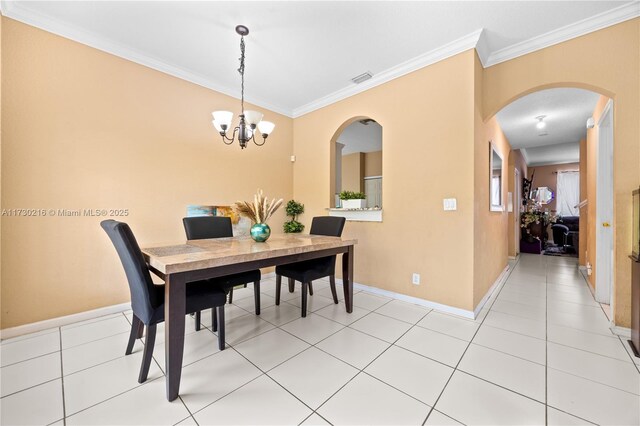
[276,216,346,317]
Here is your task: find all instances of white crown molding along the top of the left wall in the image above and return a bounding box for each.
[0,0,292,117]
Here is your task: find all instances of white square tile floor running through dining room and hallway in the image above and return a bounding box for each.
[0,255,640,425]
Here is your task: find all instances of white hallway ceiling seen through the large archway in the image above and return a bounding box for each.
[496,88,600,165]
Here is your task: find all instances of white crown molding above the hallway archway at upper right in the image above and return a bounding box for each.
[483,1,640,68]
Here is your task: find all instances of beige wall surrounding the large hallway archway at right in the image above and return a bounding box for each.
[483,18,640,327]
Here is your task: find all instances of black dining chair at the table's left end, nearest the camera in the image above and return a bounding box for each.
[100,220,227,383]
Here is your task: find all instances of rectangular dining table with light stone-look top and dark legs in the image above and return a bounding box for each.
[142,234,357,401]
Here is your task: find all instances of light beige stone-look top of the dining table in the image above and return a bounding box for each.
[142,234,358,274]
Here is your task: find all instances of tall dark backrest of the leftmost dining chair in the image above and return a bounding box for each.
[100,220,164,324]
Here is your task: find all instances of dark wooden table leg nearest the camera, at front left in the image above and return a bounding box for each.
[164,275,186,401]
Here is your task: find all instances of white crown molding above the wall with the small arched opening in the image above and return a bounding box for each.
[293,29,483,118]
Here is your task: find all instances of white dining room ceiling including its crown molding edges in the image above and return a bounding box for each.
[0,1,640,117]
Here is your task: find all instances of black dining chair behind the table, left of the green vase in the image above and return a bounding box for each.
[182,216,261,330]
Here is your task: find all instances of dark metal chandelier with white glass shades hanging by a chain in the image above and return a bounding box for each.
[212,25,276,149]
